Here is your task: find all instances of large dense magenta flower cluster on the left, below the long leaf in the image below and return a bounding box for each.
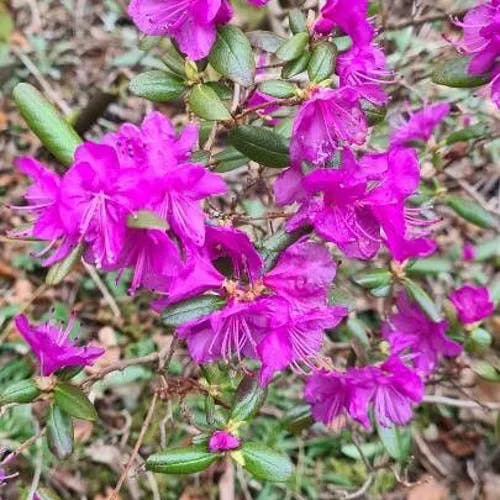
[15,112,226,291]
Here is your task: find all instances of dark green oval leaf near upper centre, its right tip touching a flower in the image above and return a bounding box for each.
[229,125,290,168]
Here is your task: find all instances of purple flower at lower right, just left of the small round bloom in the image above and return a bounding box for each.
[382,292,462,376]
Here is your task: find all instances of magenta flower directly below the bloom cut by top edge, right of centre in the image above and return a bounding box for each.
[336,44,392,105]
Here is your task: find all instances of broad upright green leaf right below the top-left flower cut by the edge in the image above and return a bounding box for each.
[209,24,255,87]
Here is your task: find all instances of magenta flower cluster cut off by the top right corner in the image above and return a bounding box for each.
[456,0,500,108]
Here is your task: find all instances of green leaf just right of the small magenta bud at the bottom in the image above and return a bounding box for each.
[241,443,293,482]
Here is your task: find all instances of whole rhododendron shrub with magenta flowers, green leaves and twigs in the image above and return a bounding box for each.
[0,0,500,495]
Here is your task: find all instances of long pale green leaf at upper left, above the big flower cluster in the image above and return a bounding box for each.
[13,83,82,165]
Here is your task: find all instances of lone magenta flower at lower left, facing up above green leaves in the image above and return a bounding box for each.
[14,314,105,376]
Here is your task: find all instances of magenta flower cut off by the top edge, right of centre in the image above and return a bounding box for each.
[314,0,375,45]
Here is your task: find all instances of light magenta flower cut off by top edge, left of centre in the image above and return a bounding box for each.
[128,0,232,61]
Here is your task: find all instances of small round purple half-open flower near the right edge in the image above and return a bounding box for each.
[449,284,495,324]
